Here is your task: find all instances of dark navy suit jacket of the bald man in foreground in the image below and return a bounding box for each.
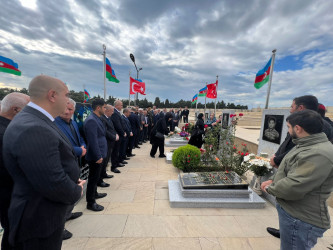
[3,106,82,244]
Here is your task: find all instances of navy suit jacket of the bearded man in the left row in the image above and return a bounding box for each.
[83,113,108,162]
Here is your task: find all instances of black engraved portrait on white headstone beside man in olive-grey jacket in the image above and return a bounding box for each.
[262,115,284,144]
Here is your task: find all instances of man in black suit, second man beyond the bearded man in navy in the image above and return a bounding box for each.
[111,100,127,173]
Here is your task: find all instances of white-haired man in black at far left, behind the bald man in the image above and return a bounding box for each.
[0,92,30,250]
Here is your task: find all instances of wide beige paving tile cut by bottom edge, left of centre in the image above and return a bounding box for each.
[84,238,153,250]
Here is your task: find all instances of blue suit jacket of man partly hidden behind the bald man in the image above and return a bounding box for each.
[55,116,87,157]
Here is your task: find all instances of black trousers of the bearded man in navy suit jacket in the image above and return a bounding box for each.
[86,162,102,203]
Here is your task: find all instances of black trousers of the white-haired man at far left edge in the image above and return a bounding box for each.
[0,187,12,250]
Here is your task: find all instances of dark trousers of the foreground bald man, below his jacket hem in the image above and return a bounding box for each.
[12,225,65,250]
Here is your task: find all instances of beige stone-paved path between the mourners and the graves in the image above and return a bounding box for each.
[62,143,333,250]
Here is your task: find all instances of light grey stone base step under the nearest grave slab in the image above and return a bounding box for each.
[168,180,266,208]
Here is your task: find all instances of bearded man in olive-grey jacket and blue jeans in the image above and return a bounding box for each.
[261,110,333,250]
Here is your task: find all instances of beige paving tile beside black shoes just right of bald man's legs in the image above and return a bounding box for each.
[66,214,127,237]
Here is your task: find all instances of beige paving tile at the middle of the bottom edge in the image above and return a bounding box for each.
[153,238,201,250]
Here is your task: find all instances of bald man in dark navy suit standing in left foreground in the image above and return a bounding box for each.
[3,75,84,250]
